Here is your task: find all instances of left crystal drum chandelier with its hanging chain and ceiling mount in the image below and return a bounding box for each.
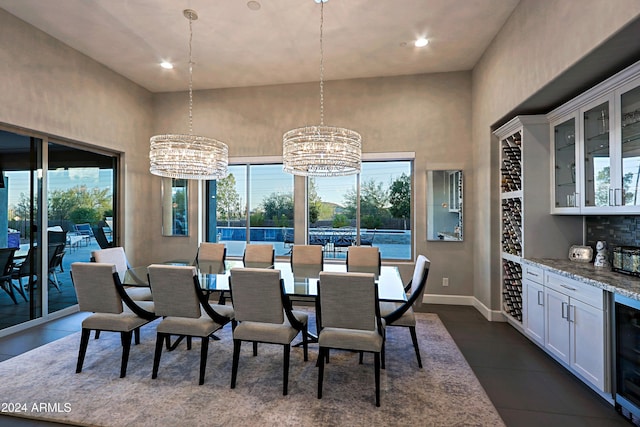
[149,9,229,180]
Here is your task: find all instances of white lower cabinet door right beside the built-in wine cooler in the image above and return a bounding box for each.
[569,299,606,391]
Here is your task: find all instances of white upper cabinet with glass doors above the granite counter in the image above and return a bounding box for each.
[547,63,640,215]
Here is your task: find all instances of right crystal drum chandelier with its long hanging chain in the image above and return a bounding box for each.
[282,0,362,176]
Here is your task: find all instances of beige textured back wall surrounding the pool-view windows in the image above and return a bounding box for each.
[154,72,475,295]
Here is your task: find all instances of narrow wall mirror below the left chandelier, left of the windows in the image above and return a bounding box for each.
[162,178,189,236]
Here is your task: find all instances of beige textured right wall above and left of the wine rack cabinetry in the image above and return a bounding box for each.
[467,0,640,310]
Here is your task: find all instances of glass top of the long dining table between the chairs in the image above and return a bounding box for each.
[122,260,407,301]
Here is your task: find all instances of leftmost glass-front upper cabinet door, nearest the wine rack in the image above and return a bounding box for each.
[551,113,580,213]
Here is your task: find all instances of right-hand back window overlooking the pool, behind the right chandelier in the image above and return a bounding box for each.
[308,160,412,259]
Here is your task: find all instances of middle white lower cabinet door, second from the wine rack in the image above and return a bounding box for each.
[544,288,570,364]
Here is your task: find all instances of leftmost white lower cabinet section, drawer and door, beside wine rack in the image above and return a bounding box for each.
[522,264,545,346]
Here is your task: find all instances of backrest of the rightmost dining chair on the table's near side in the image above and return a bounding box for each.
[318,272,380,331]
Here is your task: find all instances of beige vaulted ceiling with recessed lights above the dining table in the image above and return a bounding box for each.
[0,0,519,92]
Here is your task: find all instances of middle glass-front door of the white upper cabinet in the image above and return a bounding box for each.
[580,99,616,208]
